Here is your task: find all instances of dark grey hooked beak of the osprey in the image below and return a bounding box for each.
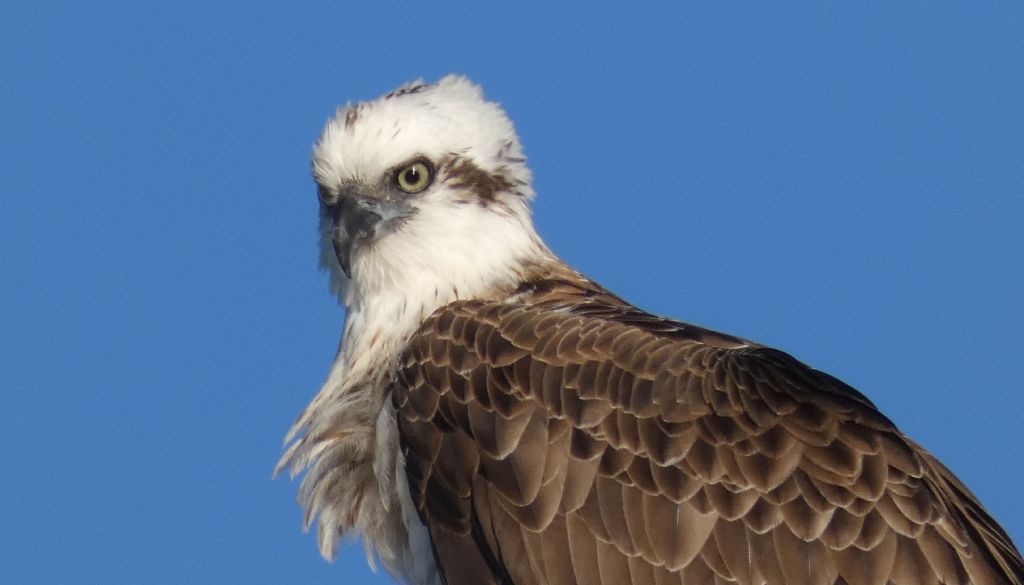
[329,191,411,278]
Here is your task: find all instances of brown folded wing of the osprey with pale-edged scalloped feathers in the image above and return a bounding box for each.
[394,280,1024,585]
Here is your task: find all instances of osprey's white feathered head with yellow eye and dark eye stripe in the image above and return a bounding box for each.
[312,76,547,306]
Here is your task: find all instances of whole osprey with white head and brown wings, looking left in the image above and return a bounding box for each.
[279,76,1024,585]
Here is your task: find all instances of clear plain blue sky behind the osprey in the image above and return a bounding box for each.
[0,2,1024,584]
